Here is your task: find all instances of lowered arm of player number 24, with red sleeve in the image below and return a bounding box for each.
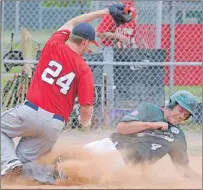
[78,69,94,127]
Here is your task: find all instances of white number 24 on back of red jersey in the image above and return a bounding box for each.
[42,61,75,95]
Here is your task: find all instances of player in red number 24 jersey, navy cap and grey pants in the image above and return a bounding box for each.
[1,8,109,176]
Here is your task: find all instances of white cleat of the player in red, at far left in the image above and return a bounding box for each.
[1,160,23,176]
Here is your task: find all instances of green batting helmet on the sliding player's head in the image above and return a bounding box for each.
[168,91,197,116]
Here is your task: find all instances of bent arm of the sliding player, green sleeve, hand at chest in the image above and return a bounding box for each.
[116,104,168,134]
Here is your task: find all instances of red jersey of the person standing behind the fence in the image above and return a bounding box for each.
[97,15,136,47]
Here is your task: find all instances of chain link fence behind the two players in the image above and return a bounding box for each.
[1,0,202,128]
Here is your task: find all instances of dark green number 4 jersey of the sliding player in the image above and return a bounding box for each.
[110,103,188,165]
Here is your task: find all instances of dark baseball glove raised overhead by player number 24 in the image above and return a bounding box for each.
[109,3,136,27]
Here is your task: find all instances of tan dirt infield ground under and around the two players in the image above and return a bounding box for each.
[1,131,202,189]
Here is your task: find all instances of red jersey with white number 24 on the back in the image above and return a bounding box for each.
[27,30,94,121]
